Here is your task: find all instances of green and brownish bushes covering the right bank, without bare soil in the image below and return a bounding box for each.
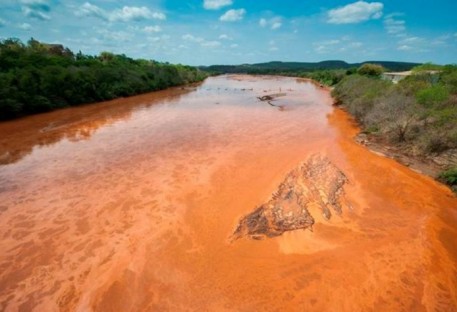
[332,64,457,185]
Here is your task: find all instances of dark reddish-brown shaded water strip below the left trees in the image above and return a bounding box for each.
[0,85,197,165]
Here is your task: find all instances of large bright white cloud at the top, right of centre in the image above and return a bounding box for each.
[327,1,384,24]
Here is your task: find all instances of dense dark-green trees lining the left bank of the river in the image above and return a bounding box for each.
[0,39,206,120]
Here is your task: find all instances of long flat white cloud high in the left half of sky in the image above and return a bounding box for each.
[76,2,166,22]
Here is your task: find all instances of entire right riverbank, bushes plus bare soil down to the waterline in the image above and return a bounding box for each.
[332,66,457,191]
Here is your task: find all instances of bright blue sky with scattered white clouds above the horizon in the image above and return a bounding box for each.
[0,0,457,65]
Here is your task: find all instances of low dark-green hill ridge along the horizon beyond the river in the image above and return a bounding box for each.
[200,60,421,74]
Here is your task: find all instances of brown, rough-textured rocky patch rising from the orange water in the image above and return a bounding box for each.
[231,155,347,241]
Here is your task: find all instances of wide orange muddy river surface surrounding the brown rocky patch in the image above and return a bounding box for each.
[0,76,457,311]
